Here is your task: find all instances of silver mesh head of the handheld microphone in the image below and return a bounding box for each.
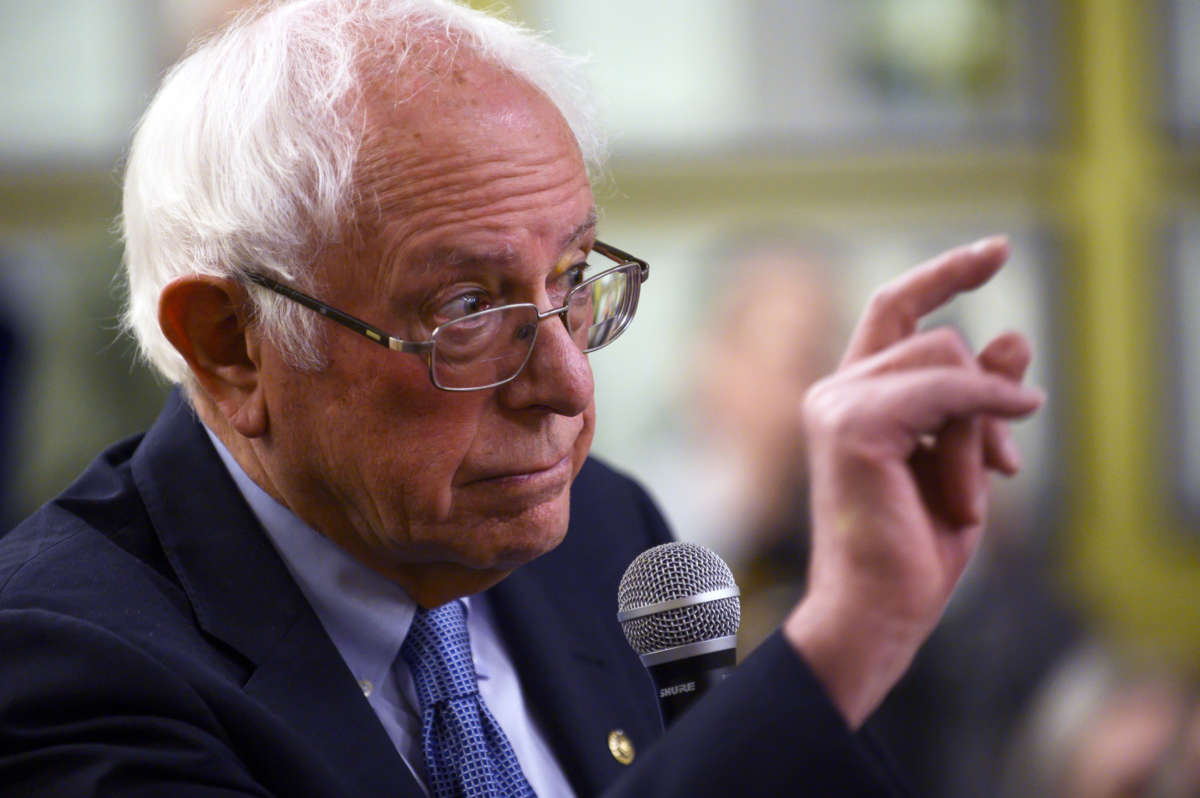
[617,542,742,655]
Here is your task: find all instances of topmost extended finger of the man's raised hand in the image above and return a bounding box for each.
[841,235,1008,366]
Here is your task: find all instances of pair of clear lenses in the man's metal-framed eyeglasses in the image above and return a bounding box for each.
[433,266,636,388]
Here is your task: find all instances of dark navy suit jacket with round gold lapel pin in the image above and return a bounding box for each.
[0,396,890,798]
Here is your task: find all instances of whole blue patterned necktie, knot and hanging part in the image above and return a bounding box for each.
[400,601,534,798]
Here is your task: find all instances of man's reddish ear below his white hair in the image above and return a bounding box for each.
[158,275,268,438]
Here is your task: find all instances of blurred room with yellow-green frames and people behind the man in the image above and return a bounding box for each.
[0,0,1200,797]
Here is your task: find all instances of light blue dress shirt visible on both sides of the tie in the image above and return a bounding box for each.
[206,430,574,798]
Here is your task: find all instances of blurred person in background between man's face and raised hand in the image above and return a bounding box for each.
[649,228,848,653]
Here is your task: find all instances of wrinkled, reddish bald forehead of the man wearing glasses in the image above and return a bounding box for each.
[324,59,594,291]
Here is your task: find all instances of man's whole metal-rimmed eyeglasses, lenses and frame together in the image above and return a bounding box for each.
[246,241,650,391]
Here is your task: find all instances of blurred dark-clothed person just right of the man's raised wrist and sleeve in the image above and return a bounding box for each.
[871,484,1085,798]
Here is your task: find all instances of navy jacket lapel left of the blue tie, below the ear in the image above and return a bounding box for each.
[133,391,425,798]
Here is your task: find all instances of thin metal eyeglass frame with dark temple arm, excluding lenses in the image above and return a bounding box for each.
[245,241,650,392]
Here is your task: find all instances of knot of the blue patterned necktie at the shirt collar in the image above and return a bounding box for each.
[400,601,479,707]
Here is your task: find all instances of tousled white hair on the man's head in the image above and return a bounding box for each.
[121,0,604,383]
